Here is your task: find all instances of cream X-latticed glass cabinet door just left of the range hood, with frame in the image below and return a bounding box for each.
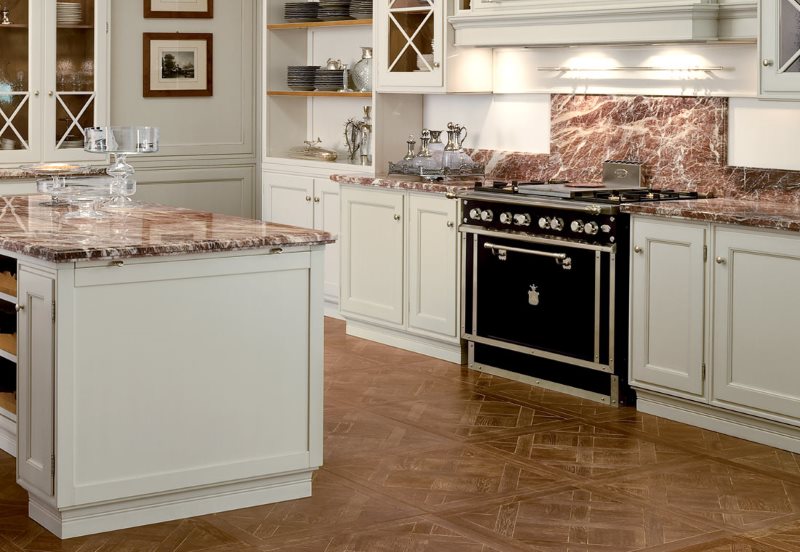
[375,0,446,91]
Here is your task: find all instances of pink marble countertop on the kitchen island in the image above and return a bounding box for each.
[0,195,334,263]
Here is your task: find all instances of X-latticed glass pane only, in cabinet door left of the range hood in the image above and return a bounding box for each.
[388,0,435,73]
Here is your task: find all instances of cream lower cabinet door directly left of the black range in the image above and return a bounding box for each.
[408,194,458,337]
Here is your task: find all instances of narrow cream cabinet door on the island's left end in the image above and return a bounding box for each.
[17,265,55,496]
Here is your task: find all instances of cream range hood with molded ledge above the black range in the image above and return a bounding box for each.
[448,0,757,47]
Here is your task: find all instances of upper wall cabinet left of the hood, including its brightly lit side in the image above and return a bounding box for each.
[375,0,492,93]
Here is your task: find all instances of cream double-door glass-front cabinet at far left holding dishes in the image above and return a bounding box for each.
[0,0,108,165]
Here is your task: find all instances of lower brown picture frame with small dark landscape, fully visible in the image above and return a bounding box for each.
[142,33,214,98]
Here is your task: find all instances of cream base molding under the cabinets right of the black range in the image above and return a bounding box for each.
[636,389,800,453]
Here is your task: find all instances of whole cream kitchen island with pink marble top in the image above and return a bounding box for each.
[0,196,332,538]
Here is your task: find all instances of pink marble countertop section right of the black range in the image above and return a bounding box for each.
[622,198,800,232]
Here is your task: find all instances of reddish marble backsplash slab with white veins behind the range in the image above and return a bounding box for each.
[471,94,800,204]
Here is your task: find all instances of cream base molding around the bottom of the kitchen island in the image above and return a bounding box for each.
[28,470,315,539]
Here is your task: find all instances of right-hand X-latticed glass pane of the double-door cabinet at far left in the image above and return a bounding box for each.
[54,0,95,149]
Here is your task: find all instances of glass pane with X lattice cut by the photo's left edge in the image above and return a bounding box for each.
[0,0,30,150]
